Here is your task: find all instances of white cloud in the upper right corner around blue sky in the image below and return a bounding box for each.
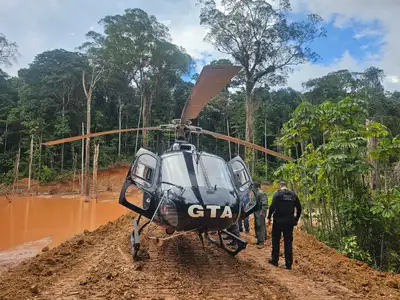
[290,0,400,90]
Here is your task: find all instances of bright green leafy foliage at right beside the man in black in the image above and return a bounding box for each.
[275,97,400,270]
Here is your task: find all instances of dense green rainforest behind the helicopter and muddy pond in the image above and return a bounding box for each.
[0,0,400,273]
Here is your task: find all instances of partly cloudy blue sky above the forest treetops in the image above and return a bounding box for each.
[0,0,400,91]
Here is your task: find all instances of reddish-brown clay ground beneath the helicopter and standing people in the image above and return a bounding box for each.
[0,214,400,300]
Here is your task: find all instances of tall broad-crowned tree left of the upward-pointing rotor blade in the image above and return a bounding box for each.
[82,9,192,149]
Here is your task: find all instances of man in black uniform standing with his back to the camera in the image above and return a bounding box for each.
[267,180,301,270]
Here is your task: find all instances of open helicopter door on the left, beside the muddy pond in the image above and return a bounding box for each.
[119,148,161,215]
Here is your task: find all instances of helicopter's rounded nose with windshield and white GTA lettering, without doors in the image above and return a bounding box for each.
[145,150,241,231]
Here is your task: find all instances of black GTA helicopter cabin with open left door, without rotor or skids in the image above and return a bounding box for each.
[120,143,256,231]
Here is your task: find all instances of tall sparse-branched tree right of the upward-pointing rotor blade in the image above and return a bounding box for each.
[199,0,325,163]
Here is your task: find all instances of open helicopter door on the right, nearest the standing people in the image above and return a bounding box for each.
[228,156,257,213]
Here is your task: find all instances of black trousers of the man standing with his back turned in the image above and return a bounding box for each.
[271,221,294,267]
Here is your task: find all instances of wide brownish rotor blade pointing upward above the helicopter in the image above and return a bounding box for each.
[181,65,242,124]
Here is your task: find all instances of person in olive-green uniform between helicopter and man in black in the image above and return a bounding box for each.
[254,182,268,248]
